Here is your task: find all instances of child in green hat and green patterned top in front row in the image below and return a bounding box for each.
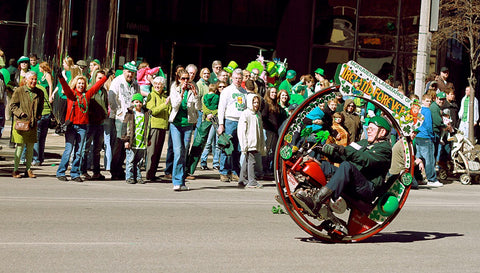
[122,93,149,184]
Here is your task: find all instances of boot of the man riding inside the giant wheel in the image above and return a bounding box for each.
[293,187,333,217]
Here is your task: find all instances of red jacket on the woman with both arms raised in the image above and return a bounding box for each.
[59,77,107,125]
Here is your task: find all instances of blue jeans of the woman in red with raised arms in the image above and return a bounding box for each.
[57,124,87,179]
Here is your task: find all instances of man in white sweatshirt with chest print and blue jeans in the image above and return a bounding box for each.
[217,68,247,182]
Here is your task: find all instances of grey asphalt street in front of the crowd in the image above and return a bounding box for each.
[0,125,480,272]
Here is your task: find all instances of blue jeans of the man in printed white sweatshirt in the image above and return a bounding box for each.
[220,119,240,175]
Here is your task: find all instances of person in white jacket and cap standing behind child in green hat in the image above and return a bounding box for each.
[108,61,140,180]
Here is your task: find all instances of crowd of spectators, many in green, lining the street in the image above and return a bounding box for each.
[0,50,479,193]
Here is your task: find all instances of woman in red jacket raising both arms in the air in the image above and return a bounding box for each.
[57,69,107,182]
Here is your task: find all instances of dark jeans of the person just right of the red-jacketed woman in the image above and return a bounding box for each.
[80,124,103,174]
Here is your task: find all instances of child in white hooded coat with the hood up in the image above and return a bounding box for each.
[237,95,265,188]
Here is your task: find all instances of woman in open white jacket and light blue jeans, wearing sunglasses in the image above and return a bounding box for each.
[168,70,202,191]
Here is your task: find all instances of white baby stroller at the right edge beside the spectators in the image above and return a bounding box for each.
[439,130,480,185]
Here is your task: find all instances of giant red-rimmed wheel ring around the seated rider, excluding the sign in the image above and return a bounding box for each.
[274,86,413,242]
